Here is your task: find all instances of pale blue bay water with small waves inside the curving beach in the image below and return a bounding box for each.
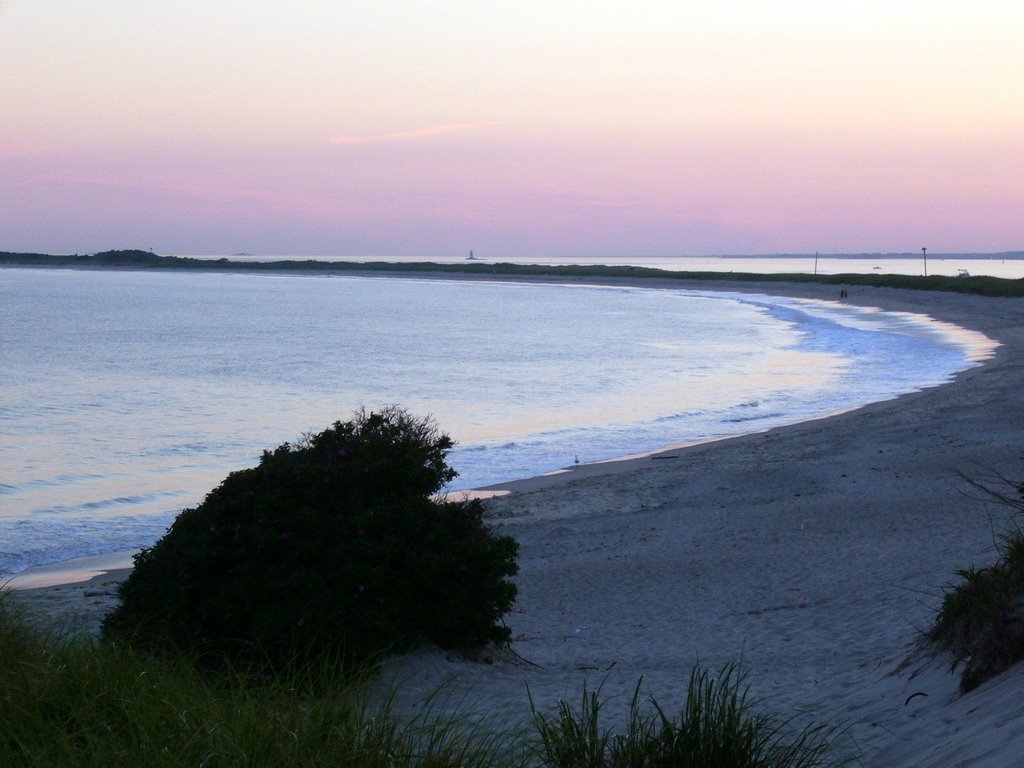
[0,269,981,574]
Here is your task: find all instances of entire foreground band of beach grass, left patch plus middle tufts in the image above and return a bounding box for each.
[0,595,843,768]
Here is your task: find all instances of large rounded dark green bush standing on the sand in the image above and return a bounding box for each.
[103,408,517,666]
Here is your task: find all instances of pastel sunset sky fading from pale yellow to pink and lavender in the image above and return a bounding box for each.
[0,0,1024,257]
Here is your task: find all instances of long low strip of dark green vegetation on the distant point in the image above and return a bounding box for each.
[6,251,1024,297]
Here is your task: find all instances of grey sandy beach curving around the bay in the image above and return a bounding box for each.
[9,280,1024,768]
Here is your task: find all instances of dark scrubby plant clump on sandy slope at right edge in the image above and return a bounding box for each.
[927,468,1024,692]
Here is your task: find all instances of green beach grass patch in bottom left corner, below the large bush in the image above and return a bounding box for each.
[0,600,527,768]
